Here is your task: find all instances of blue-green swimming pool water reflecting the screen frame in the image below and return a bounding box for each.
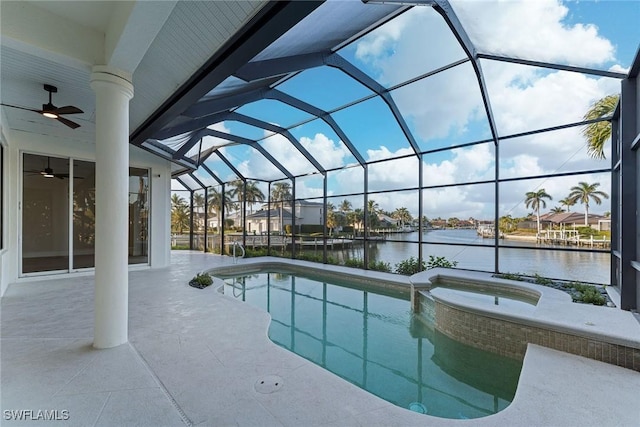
[224,272,522,419]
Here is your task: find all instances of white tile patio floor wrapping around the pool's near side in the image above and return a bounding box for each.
[0,252,640,427]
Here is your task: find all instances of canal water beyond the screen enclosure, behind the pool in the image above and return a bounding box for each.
[310,229,611,284]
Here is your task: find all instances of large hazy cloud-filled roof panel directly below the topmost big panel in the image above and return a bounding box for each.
[391,62,491,151]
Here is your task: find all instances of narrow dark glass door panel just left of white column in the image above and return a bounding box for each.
[73,160,96,269]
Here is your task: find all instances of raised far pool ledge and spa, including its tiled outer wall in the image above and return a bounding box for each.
[207,257,640,371]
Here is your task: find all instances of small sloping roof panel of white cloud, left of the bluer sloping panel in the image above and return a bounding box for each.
[291,119,357,169]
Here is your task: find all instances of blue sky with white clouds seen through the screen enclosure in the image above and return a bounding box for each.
[176,0,640,224]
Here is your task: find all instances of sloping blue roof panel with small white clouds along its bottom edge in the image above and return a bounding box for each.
[332,97,413,160]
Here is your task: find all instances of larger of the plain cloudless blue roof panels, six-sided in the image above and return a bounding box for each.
[278,67,373,111]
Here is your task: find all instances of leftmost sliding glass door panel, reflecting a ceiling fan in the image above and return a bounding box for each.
[22,154,69,273]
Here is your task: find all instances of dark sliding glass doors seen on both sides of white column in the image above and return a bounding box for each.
[22,153,149,274]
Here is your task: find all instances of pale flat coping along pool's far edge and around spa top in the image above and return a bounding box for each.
[206,257,640,349]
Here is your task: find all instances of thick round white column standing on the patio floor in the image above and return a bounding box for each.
[91,66,133,348]
